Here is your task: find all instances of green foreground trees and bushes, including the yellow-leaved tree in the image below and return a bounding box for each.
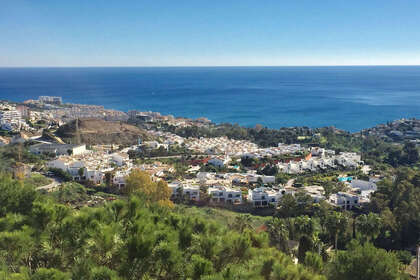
[0,172,403,280]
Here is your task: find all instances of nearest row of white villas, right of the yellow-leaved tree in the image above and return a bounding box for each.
[170,172,377,210]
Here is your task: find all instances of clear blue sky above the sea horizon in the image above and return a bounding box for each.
[0,0,420,66]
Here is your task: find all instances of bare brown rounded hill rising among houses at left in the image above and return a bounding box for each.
[56,119,148,145]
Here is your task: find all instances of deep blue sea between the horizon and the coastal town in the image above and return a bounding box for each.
[0,66,420,131]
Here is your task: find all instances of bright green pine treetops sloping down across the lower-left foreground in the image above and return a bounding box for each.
[0,176,322,279]
